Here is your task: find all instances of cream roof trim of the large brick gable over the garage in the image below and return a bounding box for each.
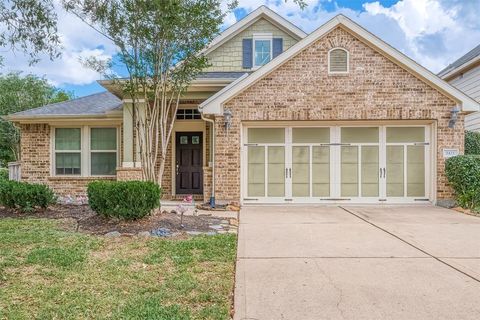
[199,15,480,114]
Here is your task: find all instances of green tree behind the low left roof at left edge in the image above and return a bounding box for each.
[0,73,72,166]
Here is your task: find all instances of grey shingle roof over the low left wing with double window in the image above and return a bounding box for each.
[10,92,122,118]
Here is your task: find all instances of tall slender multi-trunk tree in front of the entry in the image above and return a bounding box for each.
[64,0,304,185]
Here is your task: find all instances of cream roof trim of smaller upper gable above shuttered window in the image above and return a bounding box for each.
[203,6,307,54]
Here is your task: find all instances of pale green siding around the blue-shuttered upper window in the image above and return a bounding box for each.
[205,18,297,72]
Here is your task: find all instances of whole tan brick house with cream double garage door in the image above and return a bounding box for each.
[10,7,479,208]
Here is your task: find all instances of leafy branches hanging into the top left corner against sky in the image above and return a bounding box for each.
[0,0,60,64]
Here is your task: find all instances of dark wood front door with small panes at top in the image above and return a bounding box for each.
[175,132,203,194]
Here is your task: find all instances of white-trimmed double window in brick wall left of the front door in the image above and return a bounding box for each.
[53,126,118,176]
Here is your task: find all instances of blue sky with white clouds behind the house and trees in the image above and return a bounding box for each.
[0,0,480,97]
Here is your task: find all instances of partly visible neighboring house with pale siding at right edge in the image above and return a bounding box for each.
[438,45,480,131]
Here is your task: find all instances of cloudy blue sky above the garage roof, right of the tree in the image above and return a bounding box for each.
[226,0,480,72]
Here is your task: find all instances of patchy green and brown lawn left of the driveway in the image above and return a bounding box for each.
[0,219,236,320]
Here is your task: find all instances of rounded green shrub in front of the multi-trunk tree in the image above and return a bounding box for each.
[87,181,161,220]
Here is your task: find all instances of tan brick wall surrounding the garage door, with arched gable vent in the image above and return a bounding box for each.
[215,27,464,202]
